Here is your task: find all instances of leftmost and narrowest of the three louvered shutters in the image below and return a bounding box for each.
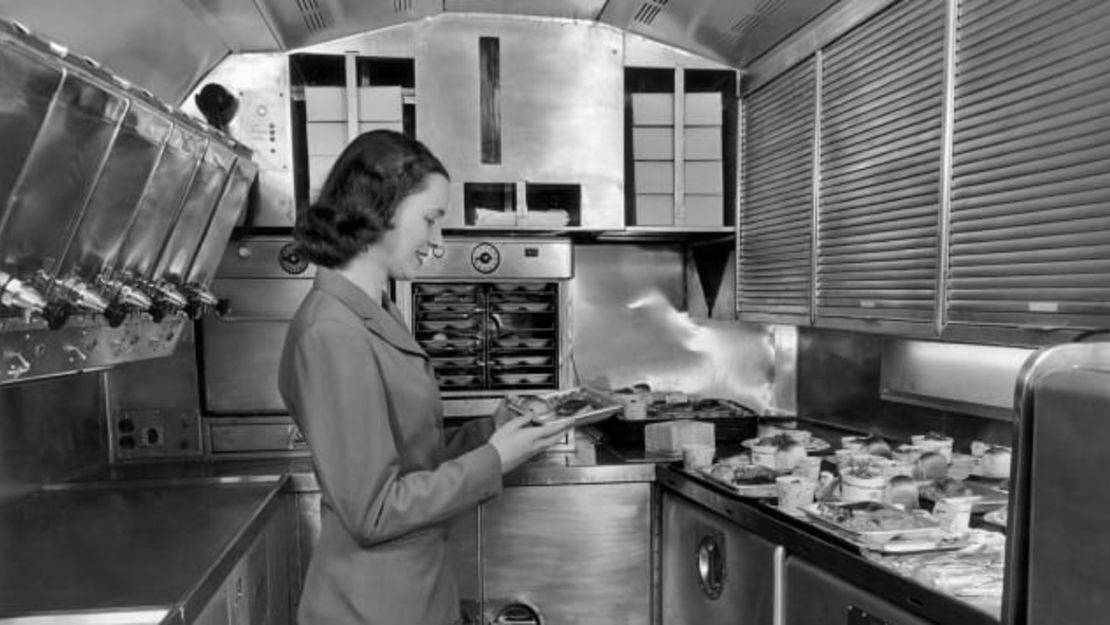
[737,59,816,323]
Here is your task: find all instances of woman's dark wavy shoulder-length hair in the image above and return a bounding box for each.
[293,130,451,268]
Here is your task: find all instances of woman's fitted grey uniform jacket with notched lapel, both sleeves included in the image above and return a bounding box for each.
[278,268,501,625]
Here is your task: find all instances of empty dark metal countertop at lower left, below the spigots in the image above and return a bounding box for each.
[0,478,285,623]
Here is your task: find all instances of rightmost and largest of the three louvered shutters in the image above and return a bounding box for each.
[948,0,1110,327]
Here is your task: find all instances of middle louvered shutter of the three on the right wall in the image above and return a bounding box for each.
[817,0,946,322]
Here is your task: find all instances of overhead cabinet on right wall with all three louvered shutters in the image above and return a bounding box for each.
[737,0,1110,341]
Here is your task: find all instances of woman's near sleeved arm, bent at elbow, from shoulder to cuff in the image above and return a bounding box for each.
[289,322,501,545]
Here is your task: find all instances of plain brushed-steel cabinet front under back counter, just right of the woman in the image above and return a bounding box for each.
[481,483,652,625]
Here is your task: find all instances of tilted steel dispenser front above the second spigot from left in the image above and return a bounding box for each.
[59,101,173,281]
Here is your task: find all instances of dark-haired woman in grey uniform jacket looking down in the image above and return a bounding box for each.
[279,131,564,625]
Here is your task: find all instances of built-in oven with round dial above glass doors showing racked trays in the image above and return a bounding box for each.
[395,238,574,416]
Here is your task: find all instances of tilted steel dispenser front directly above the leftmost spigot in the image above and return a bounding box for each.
[0,73,128,278]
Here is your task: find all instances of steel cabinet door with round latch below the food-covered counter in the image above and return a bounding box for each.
[660,493,775,625]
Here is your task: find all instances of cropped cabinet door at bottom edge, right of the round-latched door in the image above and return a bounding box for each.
[785,557,928,625]
